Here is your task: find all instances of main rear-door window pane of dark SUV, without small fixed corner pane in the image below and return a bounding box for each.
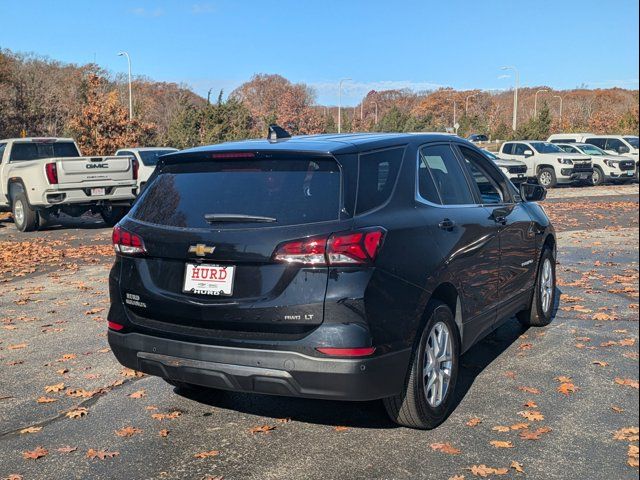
[420,145,475,205]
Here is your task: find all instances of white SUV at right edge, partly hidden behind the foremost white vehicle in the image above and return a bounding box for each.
[555,143,636,185]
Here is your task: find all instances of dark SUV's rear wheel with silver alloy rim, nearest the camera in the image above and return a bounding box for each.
[383,301,460,429]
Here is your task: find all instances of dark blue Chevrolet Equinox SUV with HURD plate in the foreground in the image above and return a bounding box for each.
[108,134,556,428]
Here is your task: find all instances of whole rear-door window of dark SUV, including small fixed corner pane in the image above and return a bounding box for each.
[418,145,476,205]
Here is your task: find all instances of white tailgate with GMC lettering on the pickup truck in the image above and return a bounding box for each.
[53,157,133,185]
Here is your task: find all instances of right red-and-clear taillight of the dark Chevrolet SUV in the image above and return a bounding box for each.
[273,227,385,265]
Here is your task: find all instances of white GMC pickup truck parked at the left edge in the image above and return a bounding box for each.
[0,138,138,232]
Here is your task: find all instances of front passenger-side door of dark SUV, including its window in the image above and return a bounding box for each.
[459,146,537,321]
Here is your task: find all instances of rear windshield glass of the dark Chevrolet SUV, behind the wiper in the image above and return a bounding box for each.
[130,158,341,228]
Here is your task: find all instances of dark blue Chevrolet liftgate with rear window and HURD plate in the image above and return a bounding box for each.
[119,152,345,341]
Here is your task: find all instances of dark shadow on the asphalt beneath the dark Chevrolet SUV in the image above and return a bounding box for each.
[174,289,561,429]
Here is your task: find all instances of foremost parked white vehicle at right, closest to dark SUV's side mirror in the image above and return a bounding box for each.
[500,141,593,188]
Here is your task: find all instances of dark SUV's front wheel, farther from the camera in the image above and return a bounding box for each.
[517,248,556,327]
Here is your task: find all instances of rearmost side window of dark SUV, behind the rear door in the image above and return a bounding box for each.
[356,147,404,215]
